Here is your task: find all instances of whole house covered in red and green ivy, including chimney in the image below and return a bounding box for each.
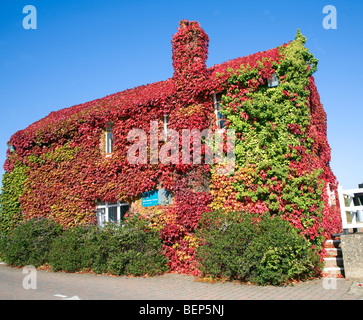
[0,20,340,272]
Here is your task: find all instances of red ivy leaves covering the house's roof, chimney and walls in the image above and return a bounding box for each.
[4,21,337,272]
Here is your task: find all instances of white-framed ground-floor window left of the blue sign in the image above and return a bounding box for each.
[97,201,130,227]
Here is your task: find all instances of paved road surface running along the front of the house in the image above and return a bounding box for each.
[0,264,363,300]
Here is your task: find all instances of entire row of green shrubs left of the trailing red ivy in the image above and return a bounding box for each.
[0,215,168,276]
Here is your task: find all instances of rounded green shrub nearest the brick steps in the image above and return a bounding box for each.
[244,216,321,285]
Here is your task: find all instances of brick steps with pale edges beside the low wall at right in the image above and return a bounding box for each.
[323,235,344,278]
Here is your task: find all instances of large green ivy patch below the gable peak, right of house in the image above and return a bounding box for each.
[213,30,336,249]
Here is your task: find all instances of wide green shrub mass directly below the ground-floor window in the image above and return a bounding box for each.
[49,212,168,276]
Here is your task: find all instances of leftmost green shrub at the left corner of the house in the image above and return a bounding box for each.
[1,218,63,267]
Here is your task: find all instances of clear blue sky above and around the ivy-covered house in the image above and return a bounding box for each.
[0,0,363,188]
